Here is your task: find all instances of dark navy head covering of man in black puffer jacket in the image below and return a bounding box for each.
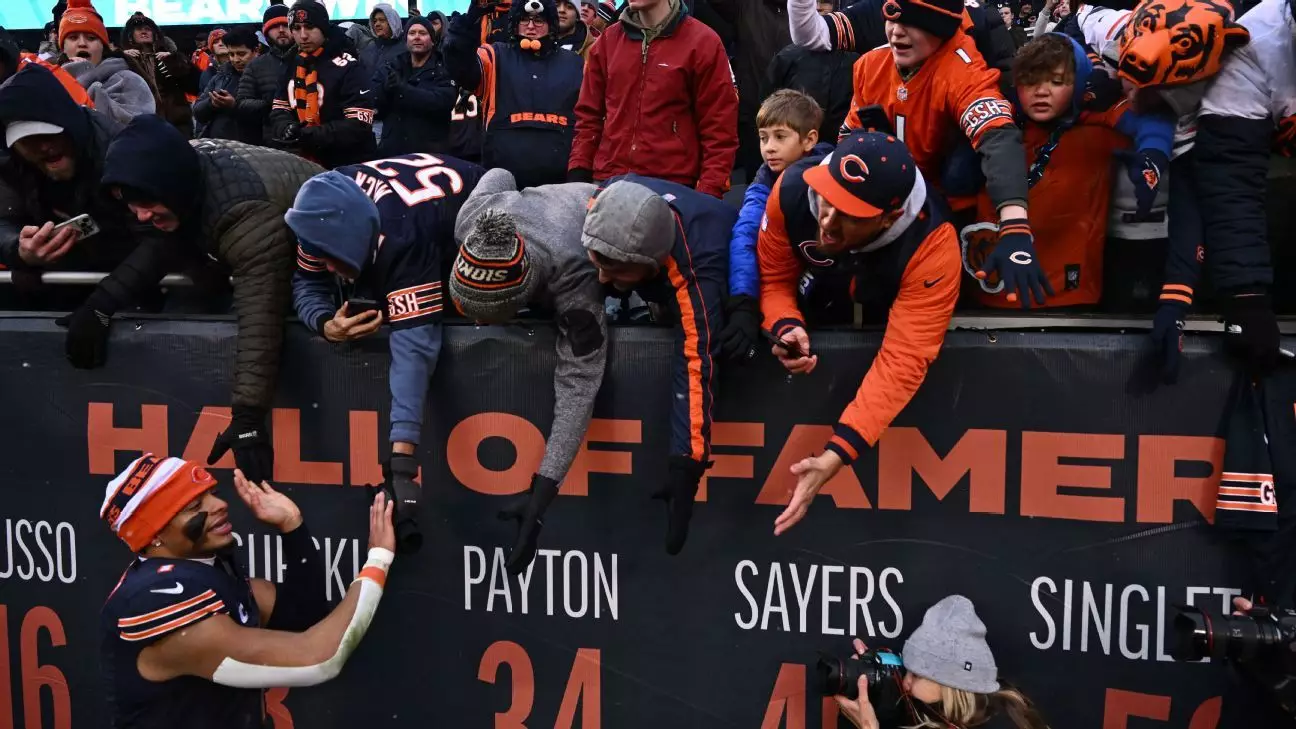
[100,114,202,224]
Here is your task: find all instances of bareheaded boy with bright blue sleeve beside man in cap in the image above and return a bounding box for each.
[721,88,831,362]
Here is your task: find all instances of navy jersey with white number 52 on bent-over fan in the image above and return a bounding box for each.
[297,153,486,329]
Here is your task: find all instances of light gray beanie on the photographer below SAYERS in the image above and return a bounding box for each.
[902,595,999,694]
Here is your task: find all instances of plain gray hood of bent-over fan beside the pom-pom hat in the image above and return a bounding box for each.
[581,180,675,267]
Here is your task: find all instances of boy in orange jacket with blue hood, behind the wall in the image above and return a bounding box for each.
[960,32,1174,307]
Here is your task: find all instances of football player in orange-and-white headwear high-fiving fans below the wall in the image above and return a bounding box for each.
[100,454,395,729]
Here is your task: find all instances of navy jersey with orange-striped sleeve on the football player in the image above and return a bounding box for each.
[100,556,264,729]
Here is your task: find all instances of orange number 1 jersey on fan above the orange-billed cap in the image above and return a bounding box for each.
[842,31,1013,194]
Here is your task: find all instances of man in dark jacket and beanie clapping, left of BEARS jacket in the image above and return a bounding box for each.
[369,17,459,157]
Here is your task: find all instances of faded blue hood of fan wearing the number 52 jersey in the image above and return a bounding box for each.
[284,171,381,272]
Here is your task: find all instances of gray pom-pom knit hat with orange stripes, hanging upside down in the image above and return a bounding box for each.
[450,204,538,322]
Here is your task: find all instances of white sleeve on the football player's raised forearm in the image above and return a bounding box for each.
[211,547,395,689]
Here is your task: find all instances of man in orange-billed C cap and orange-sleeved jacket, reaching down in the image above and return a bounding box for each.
[757,131,959,534]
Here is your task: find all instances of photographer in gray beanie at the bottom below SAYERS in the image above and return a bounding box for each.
[835,595,1048,729]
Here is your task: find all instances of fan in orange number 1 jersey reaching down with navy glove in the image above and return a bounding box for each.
[842,0,1052,309]
